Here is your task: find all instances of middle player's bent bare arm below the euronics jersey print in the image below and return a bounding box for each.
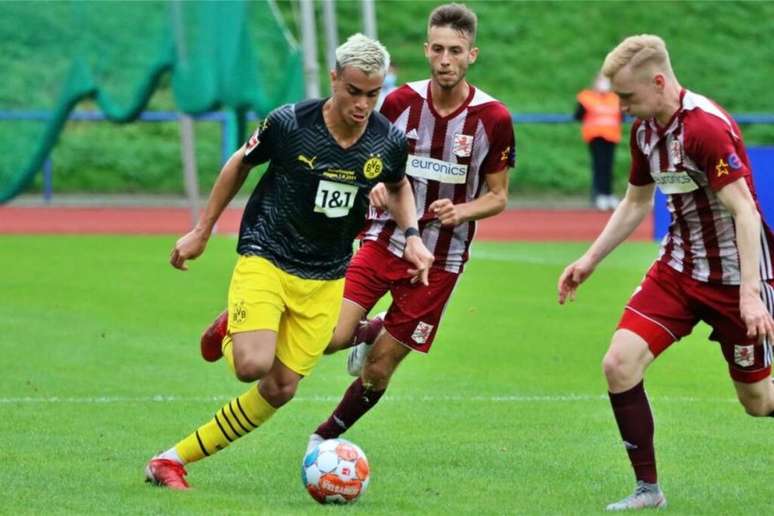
[430,167,508,226]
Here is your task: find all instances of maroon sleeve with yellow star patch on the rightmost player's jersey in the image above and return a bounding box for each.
[685,115,752,191]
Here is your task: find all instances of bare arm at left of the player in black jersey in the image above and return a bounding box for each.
[169,146,253,270]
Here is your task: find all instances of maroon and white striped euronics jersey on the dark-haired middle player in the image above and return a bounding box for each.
[363,80,515,273]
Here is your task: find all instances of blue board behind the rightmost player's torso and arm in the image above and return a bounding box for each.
[653,147,774,240]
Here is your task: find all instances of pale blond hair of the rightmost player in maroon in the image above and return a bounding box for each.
[602,34,674,79]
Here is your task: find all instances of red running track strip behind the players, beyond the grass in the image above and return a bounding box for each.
[0,206,653,241]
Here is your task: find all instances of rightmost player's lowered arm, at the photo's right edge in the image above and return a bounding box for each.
[717,177,774,340]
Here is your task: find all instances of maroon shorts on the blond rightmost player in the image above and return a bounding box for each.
[618,261,774,383]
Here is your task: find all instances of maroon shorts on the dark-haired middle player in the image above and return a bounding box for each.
[344,241,459,353]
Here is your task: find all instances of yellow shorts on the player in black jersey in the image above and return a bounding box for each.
[223,256,344,376]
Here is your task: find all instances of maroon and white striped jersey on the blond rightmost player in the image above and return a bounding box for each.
[629,90,774,285]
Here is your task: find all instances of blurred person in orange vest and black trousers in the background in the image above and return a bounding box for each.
[575,74,622,210]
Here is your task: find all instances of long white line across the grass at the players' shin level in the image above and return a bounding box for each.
[0,394,736,405]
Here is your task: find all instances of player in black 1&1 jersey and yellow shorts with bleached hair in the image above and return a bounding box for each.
[145,34,433,489]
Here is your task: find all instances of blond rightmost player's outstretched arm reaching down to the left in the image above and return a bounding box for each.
[557,183,655,304]
